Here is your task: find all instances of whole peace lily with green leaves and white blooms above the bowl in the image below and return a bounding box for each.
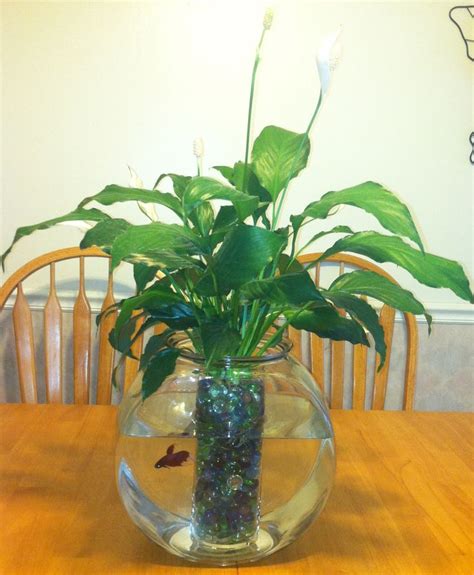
[1,12,473,398]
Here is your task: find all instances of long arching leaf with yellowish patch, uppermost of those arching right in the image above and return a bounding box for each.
[292,182,423,250]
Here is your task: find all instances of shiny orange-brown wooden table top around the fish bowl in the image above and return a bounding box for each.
[0,404,474,575]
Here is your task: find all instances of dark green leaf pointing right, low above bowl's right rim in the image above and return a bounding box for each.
[285,306,369,346]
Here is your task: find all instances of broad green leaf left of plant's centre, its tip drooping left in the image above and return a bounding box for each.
[112,222,207,268]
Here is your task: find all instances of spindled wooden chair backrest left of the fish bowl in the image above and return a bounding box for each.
[0,248,143,404]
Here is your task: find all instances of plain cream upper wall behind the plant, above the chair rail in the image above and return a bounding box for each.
[0,0,474,404]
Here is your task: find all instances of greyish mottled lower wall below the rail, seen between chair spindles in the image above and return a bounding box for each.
[0,310,474,411]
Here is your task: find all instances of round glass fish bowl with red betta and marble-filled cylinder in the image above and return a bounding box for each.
[116,336,335,565]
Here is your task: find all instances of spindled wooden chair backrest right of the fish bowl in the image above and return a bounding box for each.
[289,253,418,410]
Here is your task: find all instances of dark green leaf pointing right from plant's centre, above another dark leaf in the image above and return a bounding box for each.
[241,271,327,306]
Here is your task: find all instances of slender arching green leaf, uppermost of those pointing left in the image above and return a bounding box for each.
[78,184,183,217]
